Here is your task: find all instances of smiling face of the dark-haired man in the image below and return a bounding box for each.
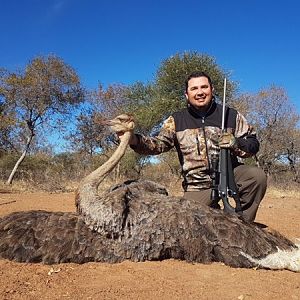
[185,76,213,111]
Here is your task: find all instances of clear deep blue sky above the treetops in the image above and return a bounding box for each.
[0,0,300,113]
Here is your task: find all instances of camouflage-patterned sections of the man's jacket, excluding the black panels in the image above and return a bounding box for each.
[132,113,255,191]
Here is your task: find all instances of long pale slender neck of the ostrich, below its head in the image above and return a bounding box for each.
[81,131,131,188]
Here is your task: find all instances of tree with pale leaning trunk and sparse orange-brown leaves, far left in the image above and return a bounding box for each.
[0,56,84,184]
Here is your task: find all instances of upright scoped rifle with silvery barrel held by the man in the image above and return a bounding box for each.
[211,78,242,216]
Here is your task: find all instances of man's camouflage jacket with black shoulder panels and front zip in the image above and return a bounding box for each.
[131,101,259,191]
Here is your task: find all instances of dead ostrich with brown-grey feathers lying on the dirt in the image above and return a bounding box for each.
[0,115,300,272]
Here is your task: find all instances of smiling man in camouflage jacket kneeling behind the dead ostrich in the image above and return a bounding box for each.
[130,72,267,222]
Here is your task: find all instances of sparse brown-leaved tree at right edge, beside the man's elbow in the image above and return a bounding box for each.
[236,85,300,181]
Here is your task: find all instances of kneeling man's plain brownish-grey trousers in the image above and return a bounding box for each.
[183,165,267,222]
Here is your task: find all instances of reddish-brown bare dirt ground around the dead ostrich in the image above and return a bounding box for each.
[0,190,300,300]
